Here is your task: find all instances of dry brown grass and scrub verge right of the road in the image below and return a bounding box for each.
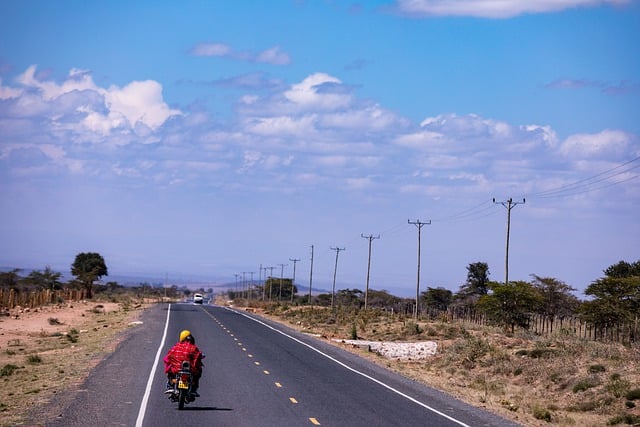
[255,307,640,427]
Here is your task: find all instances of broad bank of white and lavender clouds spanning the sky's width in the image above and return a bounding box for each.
[0,67,640,206]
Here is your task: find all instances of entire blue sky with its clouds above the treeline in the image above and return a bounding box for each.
[0,0,640,296]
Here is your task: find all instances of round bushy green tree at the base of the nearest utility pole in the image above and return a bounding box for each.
[478,281,542,332]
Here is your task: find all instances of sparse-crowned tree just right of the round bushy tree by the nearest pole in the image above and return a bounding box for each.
[531,274,580,319]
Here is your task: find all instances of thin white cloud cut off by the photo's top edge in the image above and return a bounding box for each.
[395,0,631,18]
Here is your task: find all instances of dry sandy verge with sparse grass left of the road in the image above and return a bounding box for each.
[0,302,145,426]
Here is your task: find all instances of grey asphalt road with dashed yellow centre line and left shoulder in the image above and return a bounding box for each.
[41,304,516,427]
